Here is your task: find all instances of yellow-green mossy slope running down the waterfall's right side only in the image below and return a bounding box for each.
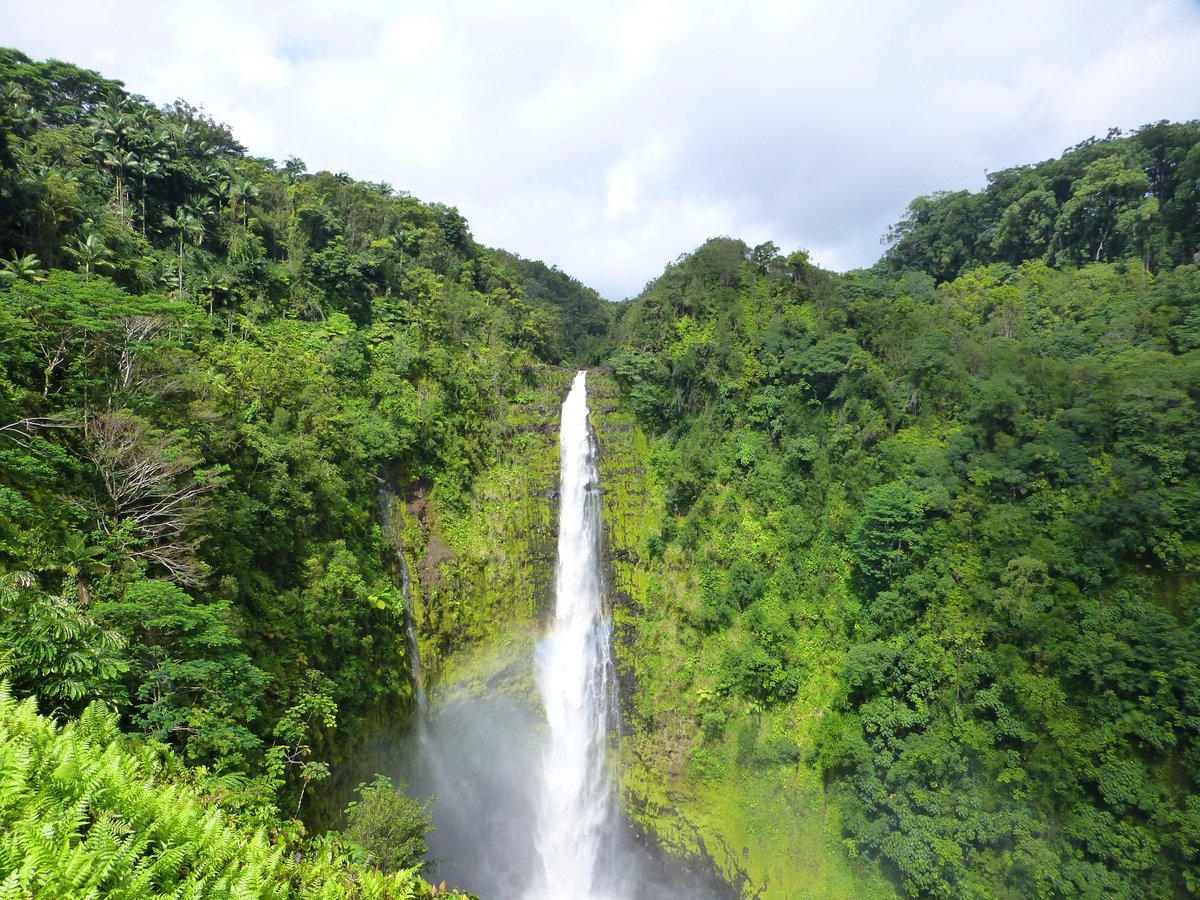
[589,377,895,900]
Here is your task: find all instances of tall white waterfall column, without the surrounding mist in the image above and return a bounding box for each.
[529,372,612,900]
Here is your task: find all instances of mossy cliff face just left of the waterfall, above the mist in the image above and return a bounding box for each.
[397,368,572,702]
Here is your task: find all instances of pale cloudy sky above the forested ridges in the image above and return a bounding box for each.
[7,0,1200,300]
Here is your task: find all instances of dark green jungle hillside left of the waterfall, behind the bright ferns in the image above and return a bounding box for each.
[0,50,607,897]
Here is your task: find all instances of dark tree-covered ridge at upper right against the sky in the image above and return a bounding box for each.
[884,121,1200,282]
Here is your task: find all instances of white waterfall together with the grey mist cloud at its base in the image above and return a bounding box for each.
[357,372,731,900]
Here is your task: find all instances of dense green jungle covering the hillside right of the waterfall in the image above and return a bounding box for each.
[613,122,1200,898]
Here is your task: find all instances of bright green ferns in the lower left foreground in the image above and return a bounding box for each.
[0,684,463,900]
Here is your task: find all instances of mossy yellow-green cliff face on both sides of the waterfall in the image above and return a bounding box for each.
[397,371,887,898]
